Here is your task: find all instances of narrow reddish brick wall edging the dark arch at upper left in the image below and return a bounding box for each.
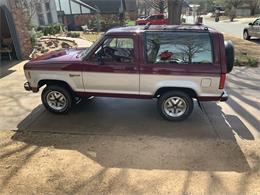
[9,0,32,59]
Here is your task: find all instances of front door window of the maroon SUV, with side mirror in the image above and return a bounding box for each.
[90,38,134,64]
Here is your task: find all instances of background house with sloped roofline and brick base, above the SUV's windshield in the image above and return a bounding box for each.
[55,0,137,26]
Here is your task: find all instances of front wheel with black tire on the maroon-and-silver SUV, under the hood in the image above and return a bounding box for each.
[41,85,73,114]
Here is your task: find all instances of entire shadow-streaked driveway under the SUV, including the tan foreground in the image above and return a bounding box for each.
[0,60,260,194]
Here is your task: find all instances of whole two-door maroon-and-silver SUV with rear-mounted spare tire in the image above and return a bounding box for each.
[24,25,234,121]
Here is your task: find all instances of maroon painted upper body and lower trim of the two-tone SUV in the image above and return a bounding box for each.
[24,25,226,101]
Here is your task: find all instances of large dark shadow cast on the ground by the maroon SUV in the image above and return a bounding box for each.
[12,98,253,172]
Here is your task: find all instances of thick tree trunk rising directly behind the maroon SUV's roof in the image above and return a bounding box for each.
[168,0,183,25]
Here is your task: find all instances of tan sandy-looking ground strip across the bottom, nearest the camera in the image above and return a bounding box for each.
[0,131,260,194]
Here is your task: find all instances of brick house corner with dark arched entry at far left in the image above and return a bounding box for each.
[0,0,32,59]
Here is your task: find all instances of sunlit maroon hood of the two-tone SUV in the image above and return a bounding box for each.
[30,49,84,63]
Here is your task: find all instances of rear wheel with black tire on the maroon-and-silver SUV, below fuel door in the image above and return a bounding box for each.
[157,91,194,122]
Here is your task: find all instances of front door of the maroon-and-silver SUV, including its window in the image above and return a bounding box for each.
[83,36,139,95]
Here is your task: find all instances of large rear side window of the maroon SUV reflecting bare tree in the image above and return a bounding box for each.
[145,31,213,64]
